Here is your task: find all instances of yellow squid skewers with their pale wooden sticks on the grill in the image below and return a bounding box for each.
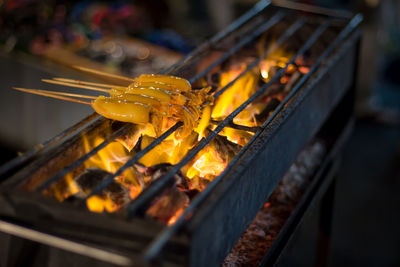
[15,67,213,138]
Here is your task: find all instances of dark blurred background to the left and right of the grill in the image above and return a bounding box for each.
[0,0,400,266]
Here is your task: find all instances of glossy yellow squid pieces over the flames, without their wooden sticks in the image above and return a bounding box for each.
[91,75,213,138]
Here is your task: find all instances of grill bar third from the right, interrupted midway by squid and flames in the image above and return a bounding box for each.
[80,18,306,207]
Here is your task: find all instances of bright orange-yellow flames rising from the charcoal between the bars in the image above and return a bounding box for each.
[44,38,309,225]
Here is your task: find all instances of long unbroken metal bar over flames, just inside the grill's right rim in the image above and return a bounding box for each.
[127,22,329,220]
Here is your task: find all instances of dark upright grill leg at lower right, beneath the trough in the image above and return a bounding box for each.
[316,177,336,266]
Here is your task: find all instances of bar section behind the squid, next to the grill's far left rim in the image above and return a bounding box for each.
[189,12,285,83]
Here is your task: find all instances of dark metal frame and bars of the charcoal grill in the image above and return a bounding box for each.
[1,1,361,266]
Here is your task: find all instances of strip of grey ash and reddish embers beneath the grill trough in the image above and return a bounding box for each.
[222,140,326,266]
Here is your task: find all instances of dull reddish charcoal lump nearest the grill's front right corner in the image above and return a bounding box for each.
[146,188,189,223]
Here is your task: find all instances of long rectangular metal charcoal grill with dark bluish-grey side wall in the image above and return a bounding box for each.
[0,1,362,266]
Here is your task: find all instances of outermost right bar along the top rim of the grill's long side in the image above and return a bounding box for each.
[145,14,362,262]
